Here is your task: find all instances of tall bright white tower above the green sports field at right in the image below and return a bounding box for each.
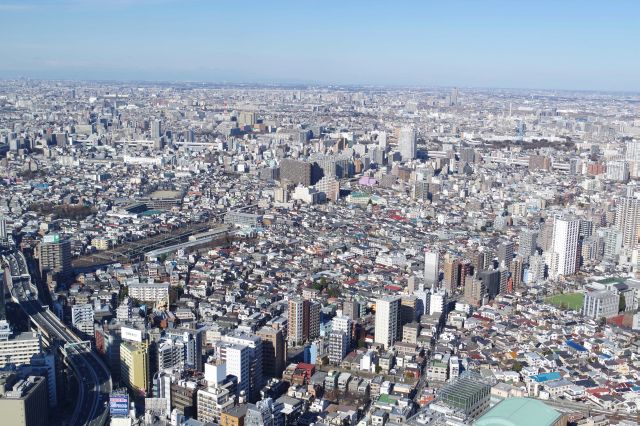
[549,216,580,277]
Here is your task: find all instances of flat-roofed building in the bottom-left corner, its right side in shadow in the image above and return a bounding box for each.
[0,372,49,426]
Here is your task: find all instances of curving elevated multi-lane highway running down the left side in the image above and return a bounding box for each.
[3,250,111,426]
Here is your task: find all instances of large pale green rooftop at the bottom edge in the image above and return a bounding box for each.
[473,398,562,426]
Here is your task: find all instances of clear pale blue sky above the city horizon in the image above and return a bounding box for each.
[0,0,640,92]
